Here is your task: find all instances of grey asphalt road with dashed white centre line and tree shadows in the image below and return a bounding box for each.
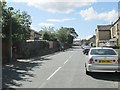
[3,46,120,88]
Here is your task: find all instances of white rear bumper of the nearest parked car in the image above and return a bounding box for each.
[87,64,120,72]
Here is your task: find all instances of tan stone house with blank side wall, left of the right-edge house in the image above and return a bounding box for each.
[96,25,112,47]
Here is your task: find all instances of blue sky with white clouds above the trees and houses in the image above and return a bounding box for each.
[6,0,119,39]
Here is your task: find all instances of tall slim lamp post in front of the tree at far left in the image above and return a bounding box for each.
[8,7,13,62]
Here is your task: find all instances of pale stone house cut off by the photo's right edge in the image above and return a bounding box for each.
[109,17,120,46]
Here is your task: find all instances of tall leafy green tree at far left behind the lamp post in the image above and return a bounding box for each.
[2,2,32,43]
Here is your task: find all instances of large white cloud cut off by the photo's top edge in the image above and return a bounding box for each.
[7,0,96,13]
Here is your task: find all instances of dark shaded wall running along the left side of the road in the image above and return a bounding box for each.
[2,41,70,64]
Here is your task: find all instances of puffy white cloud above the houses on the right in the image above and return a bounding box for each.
[80,7,118,21]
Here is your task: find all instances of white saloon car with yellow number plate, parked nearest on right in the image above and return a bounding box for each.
[85,47,120,74]
